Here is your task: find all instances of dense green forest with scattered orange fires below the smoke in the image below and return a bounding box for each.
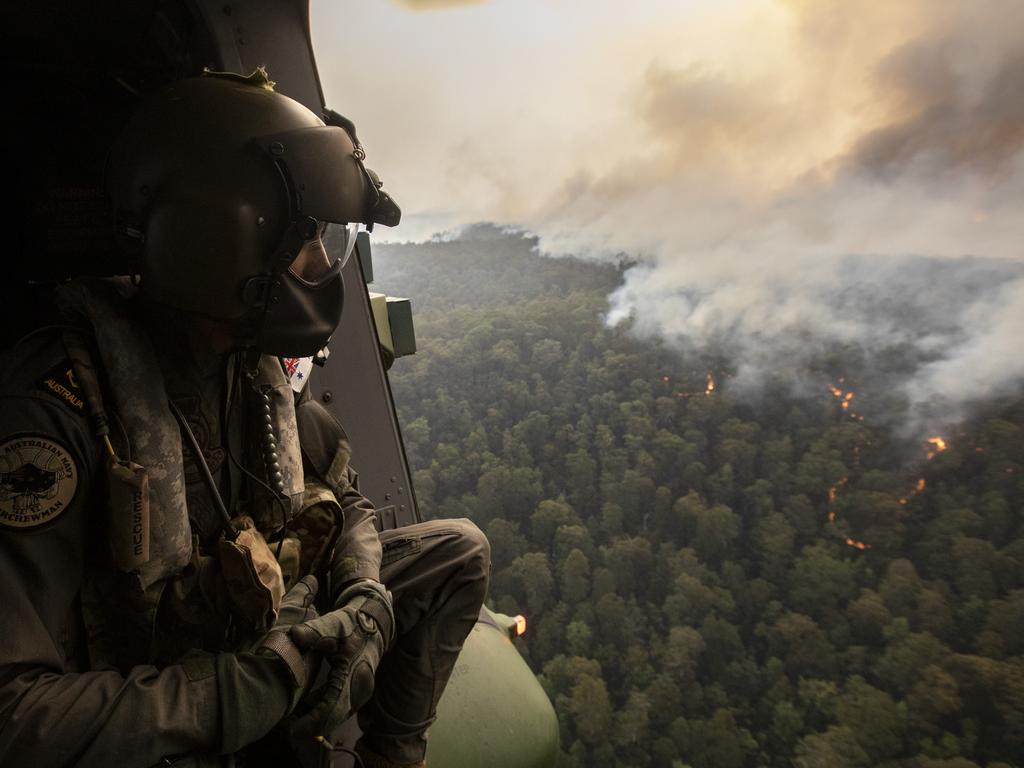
[375,228,1024,768]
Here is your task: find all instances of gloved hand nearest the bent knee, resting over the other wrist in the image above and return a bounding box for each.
[288,579,394,741]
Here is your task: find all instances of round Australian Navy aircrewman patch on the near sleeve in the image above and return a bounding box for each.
[0,435,78,528]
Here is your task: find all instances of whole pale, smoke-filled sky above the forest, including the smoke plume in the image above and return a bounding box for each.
[312,0,1024,438]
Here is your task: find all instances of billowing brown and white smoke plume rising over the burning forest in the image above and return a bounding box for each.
[520,0,1024,430]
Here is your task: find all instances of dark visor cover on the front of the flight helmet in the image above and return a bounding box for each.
[256,126,378,224]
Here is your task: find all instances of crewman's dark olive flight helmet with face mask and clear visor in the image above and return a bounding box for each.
[106,71,400,356]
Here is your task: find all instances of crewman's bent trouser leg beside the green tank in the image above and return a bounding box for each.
[359,520,490,763]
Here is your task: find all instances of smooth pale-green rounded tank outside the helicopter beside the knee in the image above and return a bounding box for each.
[427,607,558,768]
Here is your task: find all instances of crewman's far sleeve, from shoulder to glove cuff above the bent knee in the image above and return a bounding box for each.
[296,399,381,588]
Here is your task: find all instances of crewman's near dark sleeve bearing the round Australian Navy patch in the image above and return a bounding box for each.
[0,395,291,768]
